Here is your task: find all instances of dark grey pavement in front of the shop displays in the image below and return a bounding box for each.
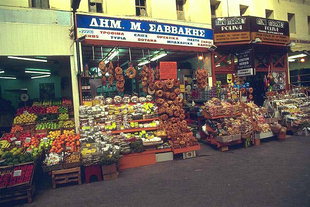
[6,136,310,207]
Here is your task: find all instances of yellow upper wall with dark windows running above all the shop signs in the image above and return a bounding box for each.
[0,0,310,41]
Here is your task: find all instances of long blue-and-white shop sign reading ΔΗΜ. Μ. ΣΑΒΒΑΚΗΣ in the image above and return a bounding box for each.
[76,14,213,48]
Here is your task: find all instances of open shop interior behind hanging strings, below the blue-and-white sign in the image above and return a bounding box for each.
[80,45,211,99]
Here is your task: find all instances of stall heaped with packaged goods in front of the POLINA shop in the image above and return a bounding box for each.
[201,98,274,151]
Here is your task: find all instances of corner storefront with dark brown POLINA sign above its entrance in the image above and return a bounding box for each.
[212,16,290,105]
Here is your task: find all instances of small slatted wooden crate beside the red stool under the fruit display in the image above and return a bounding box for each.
[52,167,82,188]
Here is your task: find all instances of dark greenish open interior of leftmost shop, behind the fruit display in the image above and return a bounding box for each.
[0,56,73,135]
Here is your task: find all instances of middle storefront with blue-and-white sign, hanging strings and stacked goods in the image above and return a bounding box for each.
[76,14,213,169]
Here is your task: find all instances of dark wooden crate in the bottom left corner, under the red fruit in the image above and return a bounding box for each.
[0,185,35,203]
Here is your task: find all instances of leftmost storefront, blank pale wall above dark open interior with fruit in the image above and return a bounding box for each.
[0,7,78,132]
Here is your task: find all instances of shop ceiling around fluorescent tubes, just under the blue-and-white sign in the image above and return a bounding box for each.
[82,45,200,67]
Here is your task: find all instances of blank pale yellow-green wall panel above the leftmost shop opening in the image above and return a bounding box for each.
[0,6,73,56]
